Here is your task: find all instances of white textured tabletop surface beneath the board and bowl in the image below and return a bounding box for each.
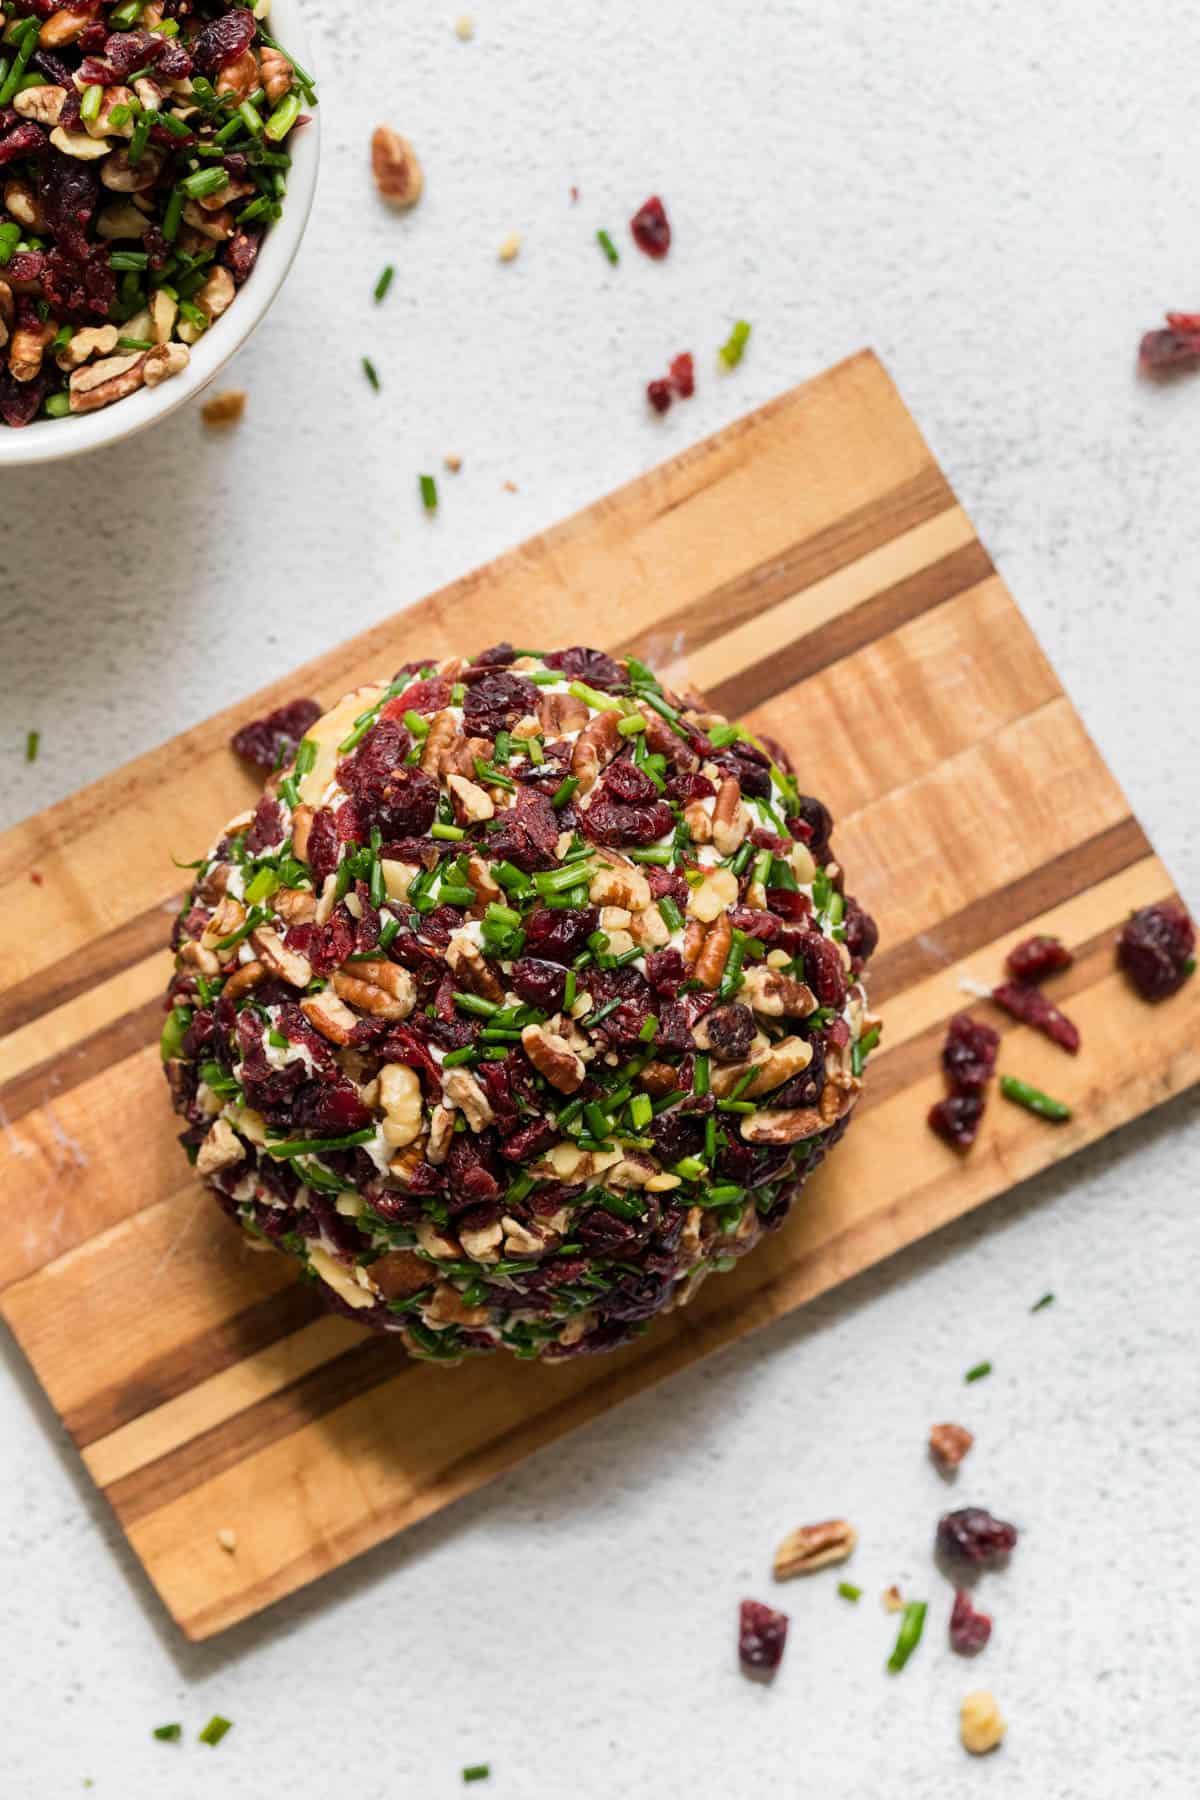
[0,0,1200,1800]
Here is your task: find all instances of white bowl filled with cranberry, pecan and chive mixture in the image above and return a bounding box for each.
[0,0,317,463]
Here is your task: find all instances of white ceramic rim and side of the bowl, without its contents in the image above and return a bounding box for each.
[0,0,320,472]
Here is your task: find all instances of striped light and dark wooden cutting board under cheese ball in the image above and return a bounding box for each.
[0,355,1200,1638]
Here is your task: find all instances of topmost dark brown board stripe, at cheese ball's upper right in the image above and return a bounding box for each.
[612,463,957,655]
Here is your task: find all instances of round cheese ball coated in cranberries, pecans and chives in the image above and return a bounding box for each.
[162,644,880,1363]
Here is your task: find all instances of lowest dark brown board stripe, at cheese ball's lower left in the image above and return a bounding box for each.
[104,1334,417,1528]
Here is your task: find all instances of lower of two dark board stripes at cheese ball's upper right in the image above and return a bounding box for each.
[707,544,995,718]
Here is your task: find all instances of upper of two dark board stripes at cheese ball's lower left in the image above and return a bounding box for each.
[71,1281,326,1451]
